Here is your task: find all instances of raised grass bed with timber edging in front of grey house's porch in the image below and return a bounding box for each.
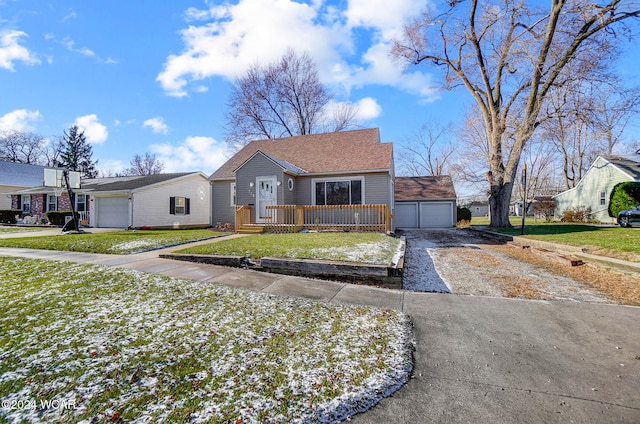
[175,232,400,265]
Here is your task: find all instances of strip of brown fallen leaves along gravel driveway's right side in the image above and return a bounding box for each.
[488,245,640,306]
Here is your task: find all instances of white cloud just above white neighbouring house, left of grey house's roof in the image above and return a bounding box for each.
[150,136,234,174]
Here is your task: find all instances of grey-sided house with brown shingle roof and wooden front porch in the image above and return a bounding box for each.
[209,128,394,231]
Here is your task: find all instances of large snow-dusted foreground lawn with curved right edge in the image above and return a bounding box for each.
[0,257,412,423]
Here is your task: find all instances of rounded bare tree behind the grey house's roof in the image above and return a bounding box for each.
[225,49,355,143]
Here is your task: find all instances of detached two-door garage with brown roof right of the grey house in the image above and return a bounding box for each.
[395,175,457,229]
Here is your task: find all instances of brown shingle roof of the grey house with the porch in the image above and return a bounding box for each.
[210,128,393,179]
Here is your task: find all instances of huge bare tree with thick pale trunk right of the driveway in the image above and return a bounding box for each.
[393,0,640,227]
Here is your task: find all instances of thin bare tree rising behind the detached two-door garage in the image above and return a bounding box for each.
[399,121,456,176]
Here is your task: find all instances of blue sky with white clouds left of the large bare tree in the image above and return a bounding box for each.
[0,0,636,179]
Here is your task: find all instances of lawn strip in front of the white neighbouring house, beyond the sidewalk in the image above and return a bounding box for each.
[0,229,229,254]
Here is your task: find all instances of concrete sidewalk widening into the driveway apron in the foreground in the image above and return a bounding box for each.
[0,246,640,423]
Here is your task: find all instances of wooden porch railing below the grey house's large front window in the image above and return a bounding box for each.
[264,205,391,233]
